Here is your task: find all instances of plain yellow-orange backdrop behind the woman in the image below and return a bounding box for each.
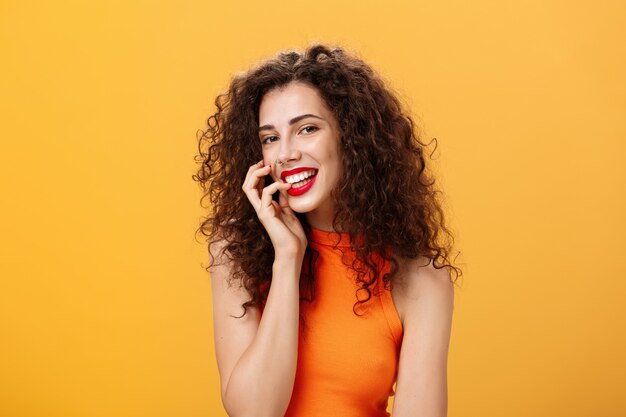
[0,0,626,417]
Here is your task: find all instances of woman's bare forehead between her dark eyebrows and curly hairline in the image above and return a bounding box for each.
[259,82,330,120]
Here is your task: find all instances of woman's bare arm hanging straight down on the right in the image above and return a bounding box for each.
[392,262,454,417]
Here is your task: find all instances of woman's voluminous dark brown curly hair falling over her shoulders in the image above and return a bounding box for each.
[192,44,462,317]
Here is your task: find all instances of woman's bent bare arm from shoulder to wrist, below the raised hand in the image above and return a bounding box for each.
[210,237,301,417]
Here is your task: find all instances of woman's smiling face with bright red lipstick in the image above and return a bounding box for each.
[259,82,343,231]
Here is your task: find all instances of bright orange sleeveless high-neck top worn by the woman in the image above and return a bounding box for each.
[285,228,403,417]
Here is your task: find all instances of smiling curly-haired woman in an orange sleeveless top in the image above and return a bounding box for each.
[194,44,460,417]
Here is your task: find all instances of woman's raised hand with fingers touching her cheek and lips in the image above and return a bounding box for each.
[241,161,307,260]
